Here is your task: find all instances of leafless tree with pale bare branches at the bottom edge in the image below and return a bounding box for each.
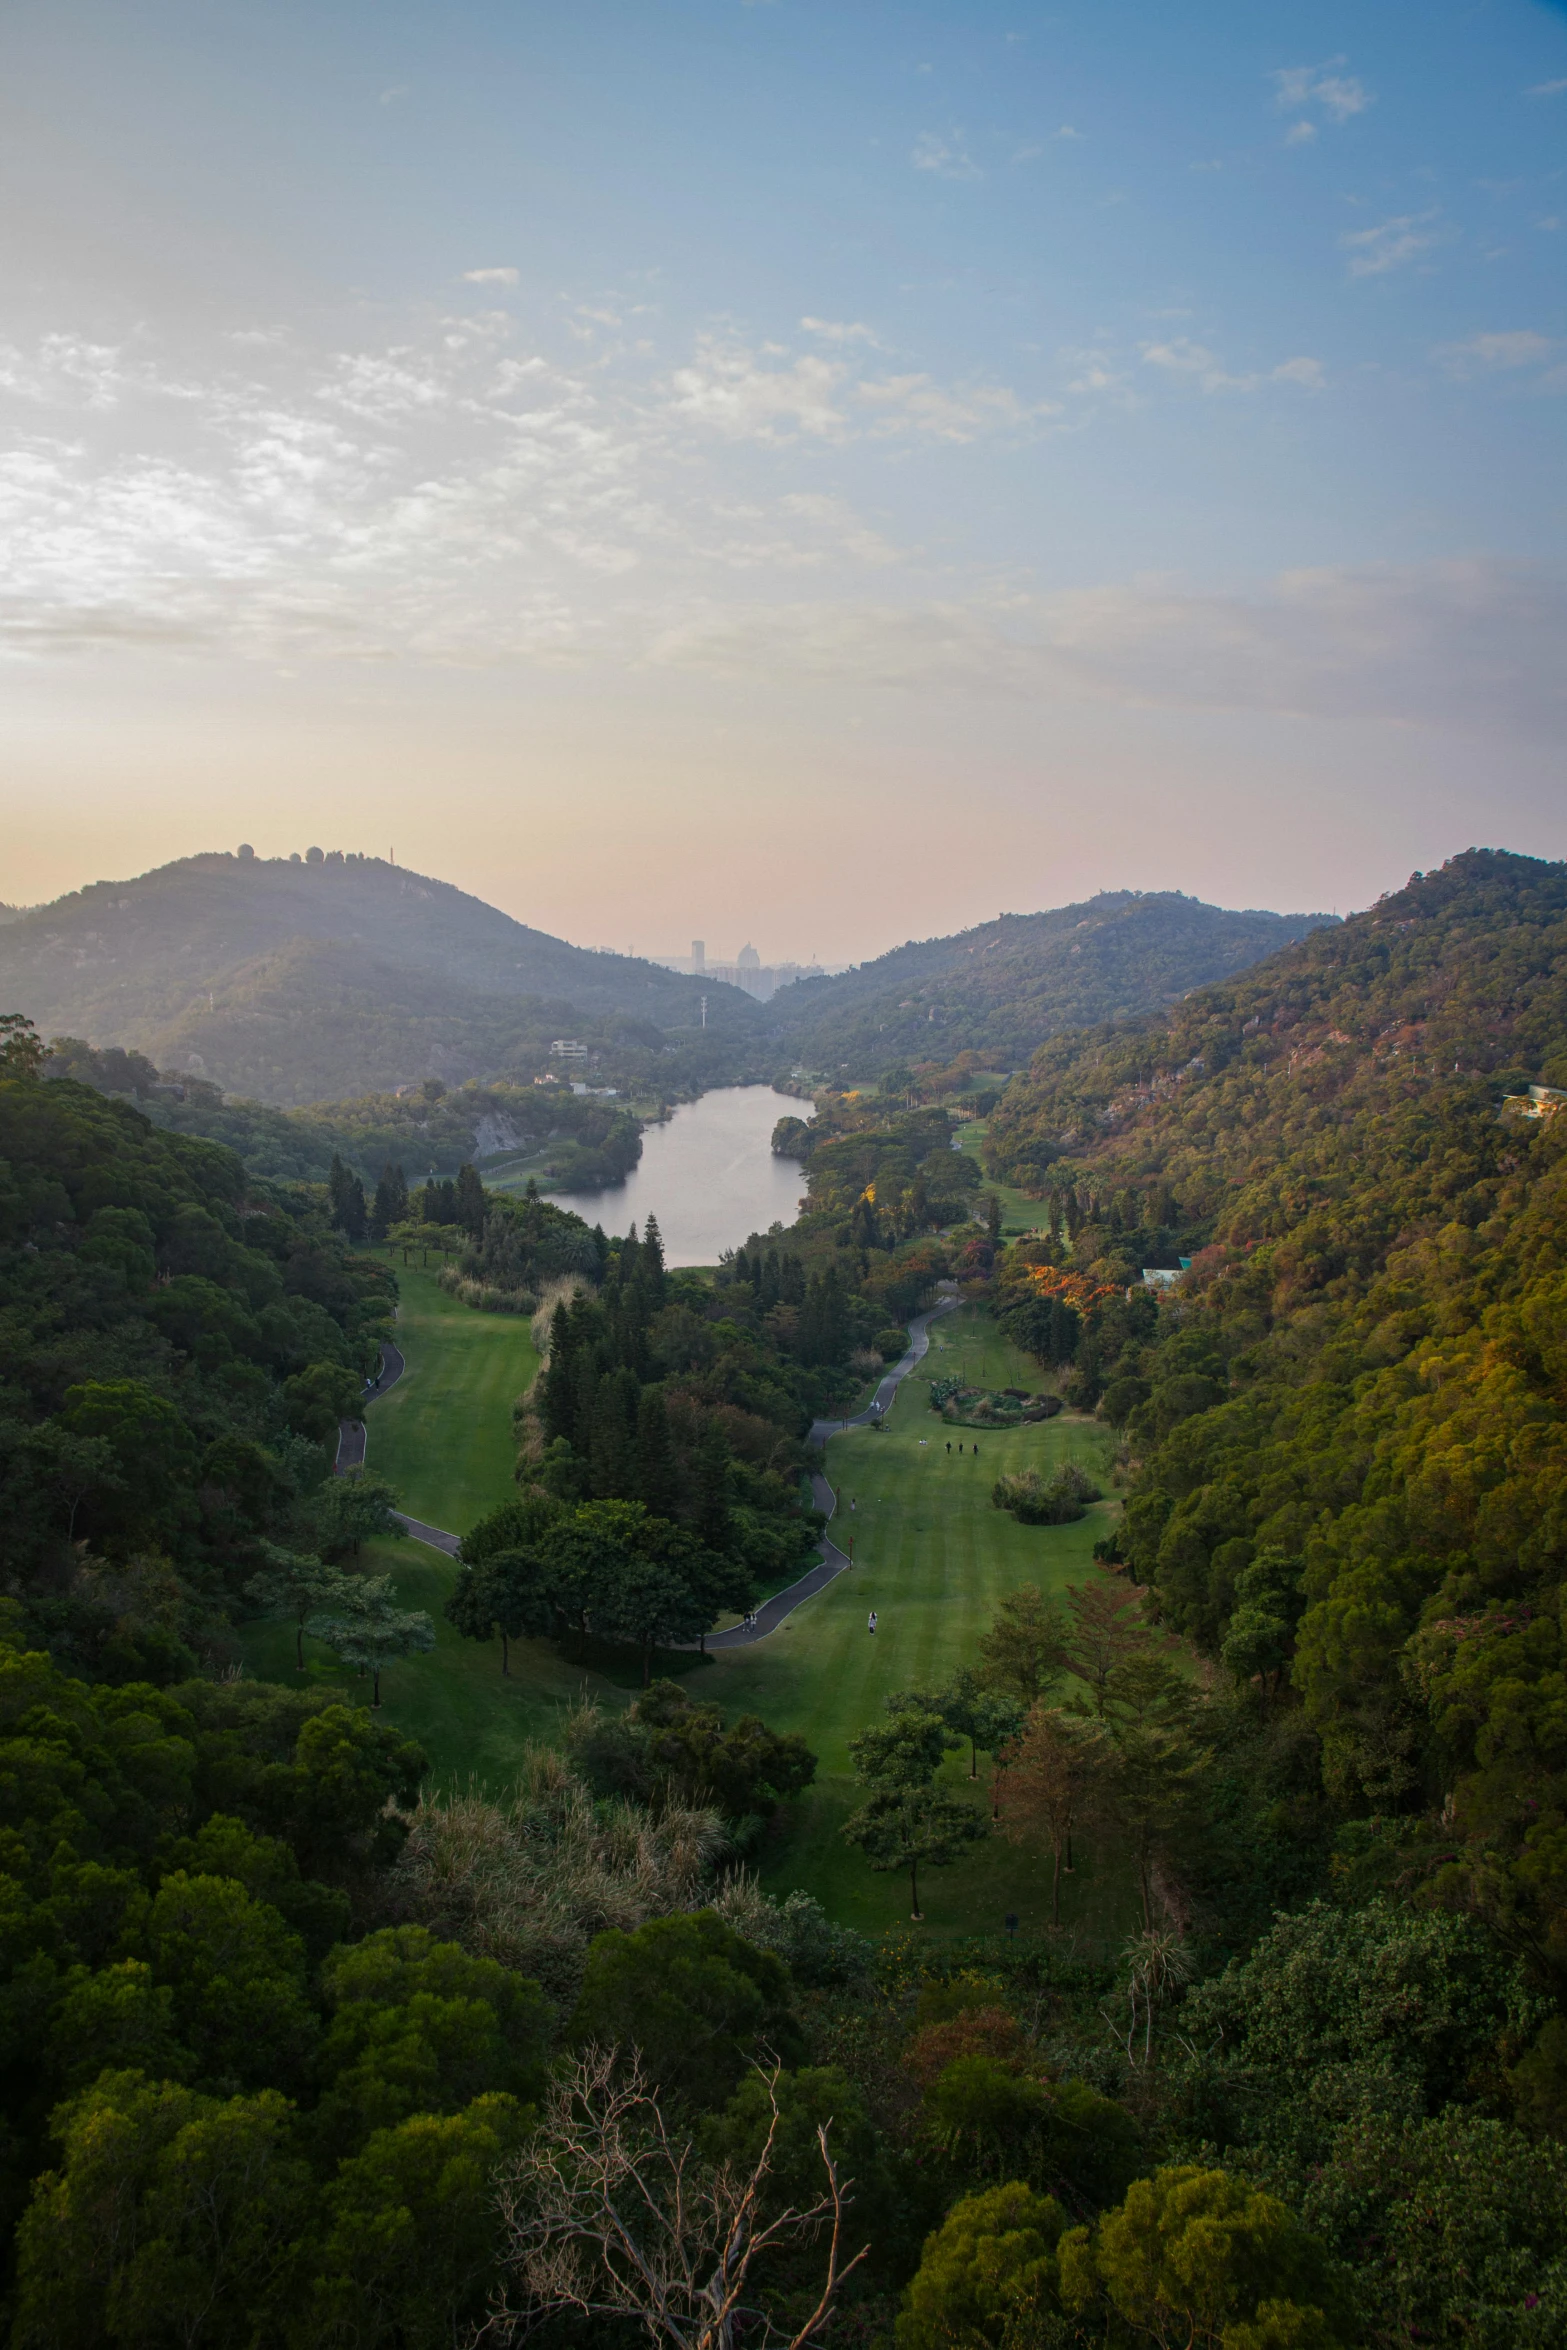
[486,2047,867,2350]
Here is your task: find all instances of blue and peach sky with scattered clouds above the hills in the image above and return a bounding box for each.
[0,0,1567,964]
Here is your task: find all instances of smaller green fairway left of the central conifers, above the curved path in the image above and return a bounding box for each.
[364,1264,538,1535]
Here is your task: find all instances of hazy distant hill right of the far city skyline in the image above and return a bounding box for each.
[771,891,1332,1076]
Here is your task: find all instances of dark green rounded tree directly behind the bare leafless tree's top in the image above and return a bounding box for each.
[569,1911,799,2108]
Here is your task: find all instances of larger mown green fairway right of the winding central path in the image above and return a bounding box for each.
[702,1307,1132,1943]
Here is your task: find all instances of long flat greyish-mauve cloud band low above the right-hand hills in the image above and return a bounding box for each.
[653,562,1567,738]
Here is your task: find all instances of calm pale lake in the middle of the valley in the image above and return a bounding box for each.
[606,1086,813,1264]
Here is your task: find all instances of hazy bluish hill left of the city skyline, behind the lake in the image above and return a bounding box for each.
[0,851,766,1105]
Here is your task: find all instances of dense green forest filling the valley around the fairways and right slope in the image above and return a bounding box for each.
[0,853,1567,2350]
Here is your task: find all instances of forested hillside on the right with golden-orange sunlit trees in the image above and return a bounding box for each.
[991,851,1567,2011]
